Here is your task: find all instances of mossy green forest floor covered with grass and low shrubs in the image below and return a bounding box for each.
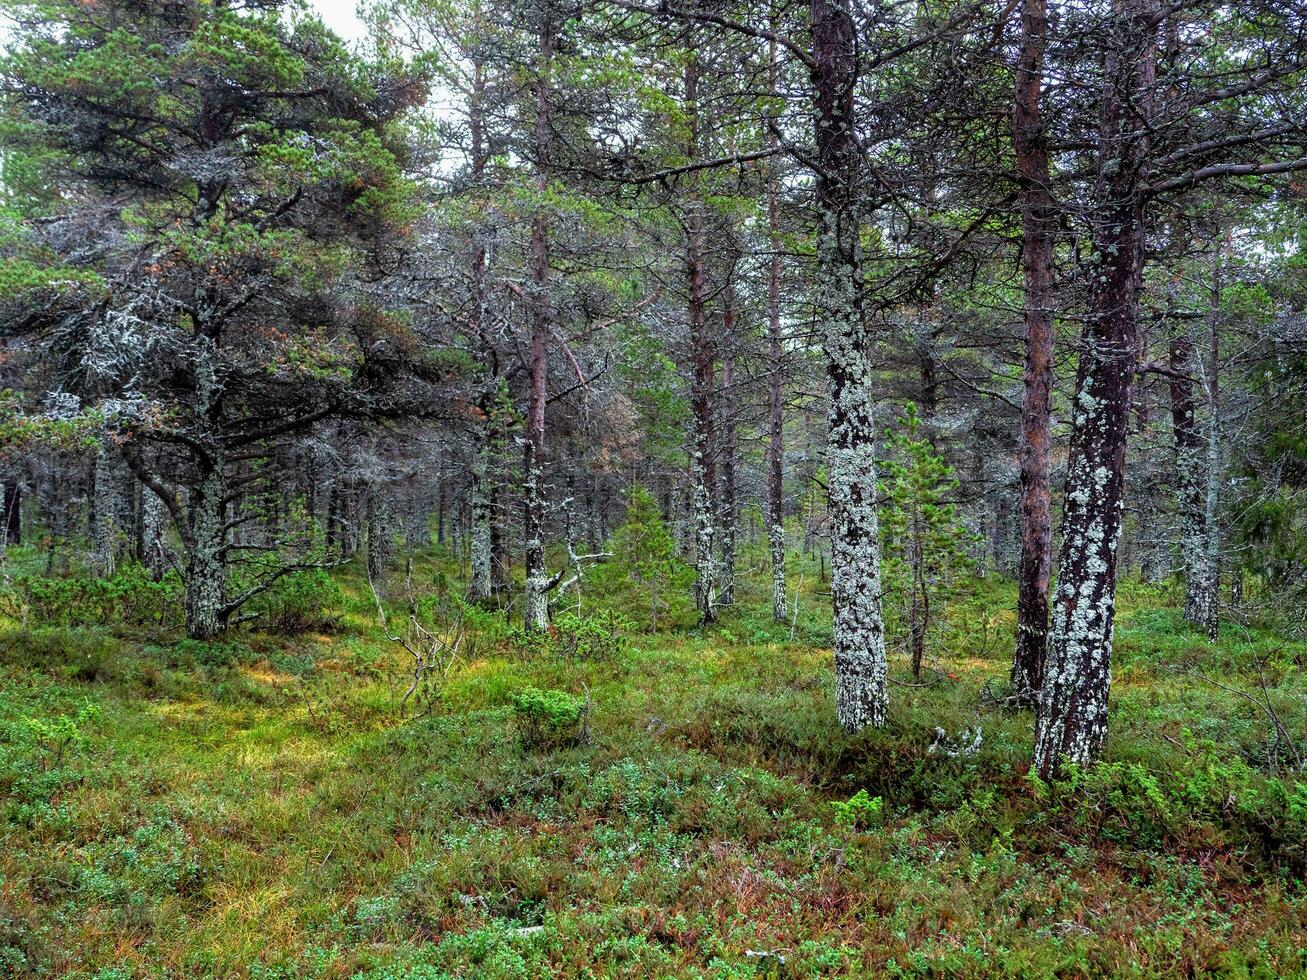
[0,556,1307,980]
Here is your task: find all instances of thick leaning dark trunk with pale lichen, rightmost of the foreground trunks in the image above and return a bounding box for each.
[1034,0,1157,779]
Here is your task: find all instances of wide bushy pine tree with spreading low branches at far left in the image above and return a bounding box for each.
[0,0,428,638]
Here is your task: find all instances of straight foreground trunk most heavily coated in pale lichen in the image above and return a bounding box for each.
[810,0,889,732]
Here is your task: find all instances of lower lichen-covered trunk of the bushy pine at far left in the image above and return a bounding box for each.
[183,461,227,640]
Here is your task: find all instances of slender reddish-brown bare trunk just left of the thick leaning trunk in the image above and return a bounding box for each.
[1012,0,1056,706]
